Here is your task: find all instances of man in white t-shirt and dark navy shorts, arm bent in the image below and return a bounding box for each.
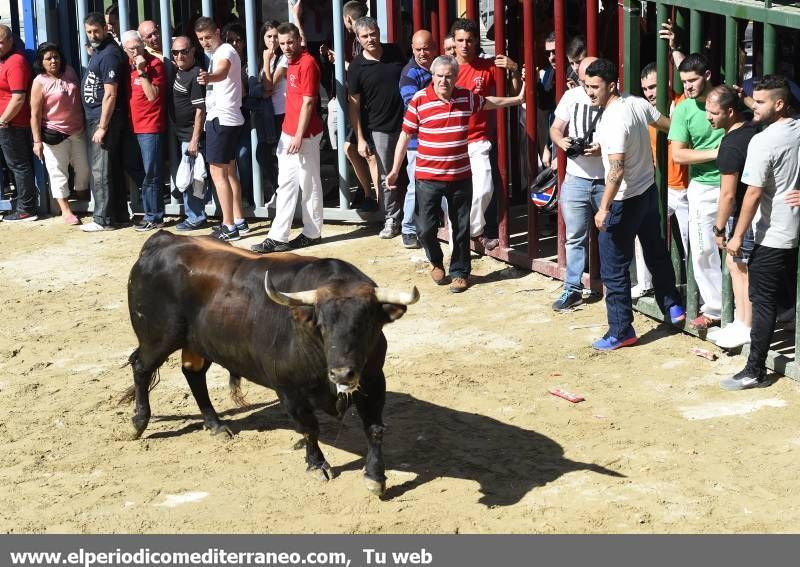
[194,17,244,242]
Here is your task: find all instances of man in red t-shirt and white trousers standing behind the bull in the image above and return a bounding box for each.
[251,23,322,254]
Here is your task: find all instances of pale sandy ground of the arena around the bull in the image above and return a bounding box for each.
[0,218,800,533]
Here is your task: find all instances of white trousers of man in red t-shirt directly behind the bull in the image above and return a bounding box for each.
[268,132,322,242]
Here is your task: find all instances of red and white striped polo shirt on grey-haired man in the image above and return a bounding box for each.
[403,85,485,181]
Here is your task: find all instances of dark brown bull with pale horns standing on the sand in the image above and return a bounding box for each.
[123,231,419,495]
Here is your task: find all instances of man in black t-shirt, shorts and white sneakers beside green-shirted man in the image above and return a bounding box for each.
[706,85,758,348]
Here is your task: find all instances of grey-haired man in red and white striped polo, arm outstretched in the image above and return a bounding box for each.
[386,55,525,293]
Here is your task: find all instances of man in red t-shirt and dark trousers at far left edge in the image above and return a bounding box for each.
[0,25,38,222]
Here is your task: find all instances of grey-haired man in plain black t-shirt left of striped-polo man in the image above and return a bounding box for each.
[347,17,406,238]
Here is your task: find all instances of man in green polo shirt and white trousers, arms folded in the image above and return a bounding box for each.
[669,53,725,329]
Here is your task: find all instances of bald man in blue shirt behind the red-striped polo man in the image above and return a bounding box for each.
[400,30,435,248]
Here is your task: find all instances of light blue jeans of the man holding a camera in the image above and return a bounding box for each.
[558,174,606,292]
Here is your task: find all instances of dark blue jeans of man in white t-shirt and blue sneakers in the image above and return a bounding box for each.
[598,184,682,337]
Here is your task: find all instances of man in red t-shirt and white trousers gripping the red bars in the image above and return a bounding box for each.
[450,18,520,250]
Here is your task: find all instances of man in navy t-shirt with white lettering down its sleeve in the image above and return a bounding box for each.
[81,12,130,232]
